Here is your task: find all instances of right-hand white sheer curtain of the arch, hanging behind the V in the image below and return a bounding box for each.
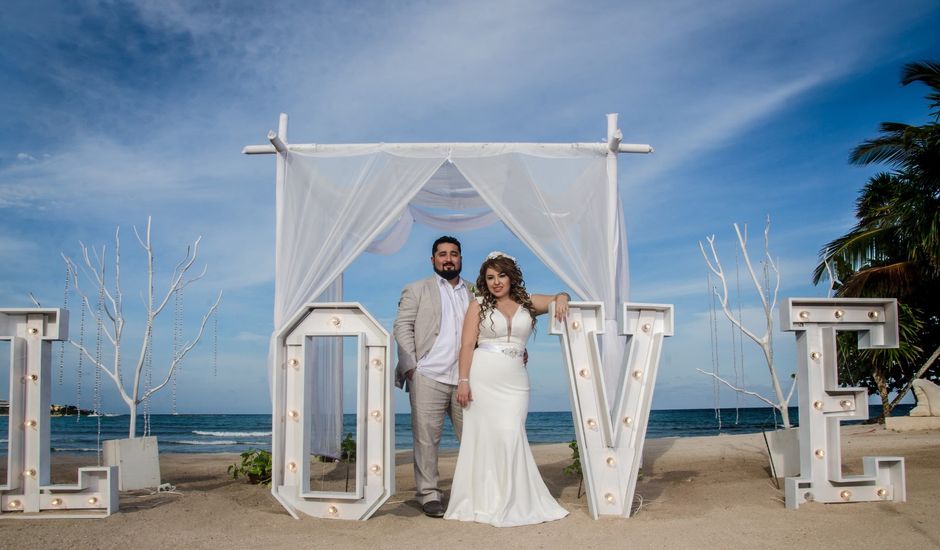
[454,153,629,396]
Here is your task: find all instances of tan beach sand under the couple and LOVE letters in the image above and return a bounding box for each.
[0,426,940,550]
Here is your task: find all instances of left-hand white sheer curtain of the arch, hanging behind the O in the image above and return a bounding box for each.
[269,151,443,457]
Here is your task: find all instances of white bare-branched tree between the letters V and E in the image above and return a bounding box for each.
[696,216,796,428]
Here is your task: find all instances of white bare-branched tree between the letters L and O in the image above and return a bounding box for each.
[62,216,222,438]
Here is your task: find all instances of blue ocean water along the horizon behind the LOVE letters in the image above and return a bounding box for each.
[0,405,913,454]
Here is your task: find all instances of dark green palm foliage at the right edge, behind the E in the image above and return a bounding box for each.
[813,61,940,422]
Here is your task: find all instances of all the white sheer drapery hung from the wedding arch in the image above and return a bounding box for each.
[280,144,628,454]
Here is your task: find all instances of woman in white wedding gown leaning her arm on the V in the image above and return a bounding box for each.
[444,252,568,527]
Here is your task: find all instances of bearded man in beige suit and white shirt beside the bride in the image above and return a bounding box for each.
[394,236,472,518]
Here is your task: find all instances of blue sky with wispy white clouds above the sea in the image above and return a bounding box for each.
[0,0,940,412]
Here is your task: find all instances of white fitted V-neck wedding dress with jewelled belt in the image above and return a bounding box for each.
[444,307,568,527]
